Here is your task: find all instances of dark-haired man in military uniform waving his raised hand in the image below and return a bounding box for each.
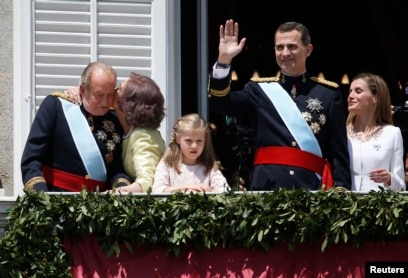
[209,20,351,191]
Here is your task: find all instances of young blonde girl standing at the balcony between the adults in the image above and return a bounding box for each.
[152,114,229,193]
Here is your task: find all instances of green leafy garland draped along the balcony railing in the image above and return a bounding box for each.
[0,189,408,277]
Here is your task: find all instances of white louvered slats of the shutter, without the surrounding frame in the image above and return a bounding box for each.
[33,0,152,110]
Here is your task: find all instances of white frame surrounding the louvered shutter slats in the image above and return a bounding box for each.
[13,0,181,196]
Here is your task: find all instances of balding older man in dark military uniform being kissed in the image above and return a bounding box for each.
[21,62,130,192]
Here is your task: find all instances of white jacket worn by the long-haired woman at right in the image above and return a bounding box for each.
[347,125,405,192]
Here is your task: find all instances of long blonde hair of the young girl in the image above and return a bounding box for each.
[163,113,217,174]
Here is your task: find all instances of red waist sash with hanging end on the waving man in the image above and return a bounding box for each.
[254,147,333,190]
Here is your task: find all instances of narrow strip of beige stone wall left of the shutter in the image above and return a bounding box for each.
[0,0,13,196]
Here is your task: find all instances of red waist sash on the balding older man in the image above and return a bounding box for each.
[42,166,106,192]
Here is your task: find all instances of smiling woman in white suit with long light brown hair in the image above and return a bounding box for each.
[346,73,405,192]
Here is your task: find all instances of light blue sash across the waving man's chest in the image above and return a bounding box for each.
[258,82,322,157]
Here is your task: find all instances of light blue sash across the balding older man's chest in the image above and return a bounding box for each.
[59,98,106,182]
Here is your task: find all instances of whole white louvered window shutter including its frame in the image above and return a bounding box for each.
[13,0,181,195]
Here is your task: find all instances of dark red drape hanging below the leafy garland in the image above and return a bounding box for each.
[65,236,408,278]
